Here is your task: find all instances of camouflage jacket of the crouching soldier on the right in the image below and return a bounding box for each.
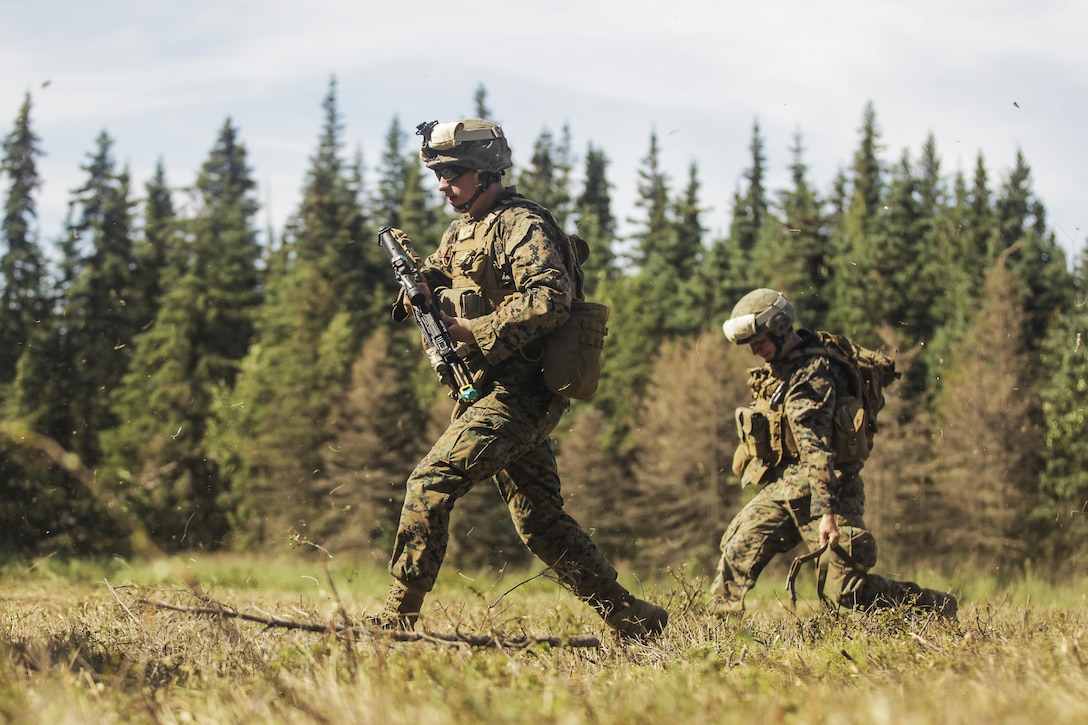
[764,330,861,517]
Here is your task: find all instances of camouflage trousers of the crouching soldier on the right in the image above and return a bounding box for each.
[710,483,922,610]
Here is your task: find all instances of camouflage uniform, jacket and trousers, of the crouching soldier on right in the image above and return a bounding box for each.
[710,330,937,612]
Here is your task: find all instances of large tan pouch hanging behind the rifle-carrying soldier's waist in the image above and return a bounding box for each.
[541,299,609,400]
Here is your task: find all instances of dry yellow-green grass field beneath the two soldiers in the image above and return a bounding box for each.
[0,556,1088,725]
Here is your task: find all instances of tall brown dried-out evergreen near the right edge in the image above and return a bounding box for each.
[934,260,1042,566]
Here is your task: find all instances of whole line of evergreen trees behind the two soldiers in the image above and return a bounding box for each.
[0,78,1088,570]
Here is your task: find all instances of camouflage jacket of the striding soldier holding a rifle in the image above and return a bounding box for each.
[420,187,572,371]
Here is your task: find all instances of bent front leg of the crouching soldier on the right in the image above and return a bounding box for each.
[707,488,807,616]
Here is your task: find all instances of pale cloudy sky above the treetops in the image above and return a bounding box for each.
[0,0,1088,260]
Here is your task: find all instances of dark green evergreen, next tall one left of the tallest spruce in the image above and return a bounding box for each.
[104,119,262,551]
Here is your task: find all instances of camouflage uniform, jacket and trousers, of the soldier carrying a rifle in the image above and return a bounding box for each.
[390,188,664,626]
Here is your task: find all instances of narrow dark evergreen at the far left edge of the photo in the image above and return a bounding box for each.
[0,94,49,383]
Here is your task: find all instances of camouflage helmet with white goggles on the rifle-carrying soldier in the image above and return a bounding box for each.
[416,119,514,174]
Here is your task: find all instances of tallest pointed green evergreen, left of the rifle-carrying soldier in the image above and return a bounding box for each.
[214,81,378,546]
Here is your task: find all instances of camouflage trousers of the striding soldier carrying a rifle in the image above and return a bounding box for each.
[390,374,617,599]
